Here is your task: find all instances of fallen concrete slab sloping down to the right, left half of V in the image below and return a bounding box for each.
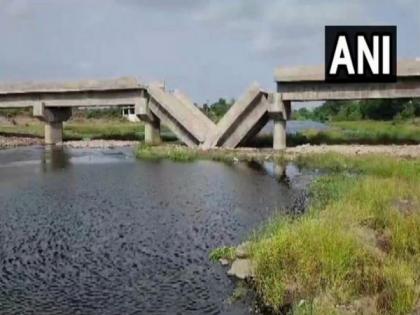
[147,85,215,147]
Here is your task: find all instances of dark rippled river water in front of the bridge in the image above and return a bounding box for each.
[0,147,311,315]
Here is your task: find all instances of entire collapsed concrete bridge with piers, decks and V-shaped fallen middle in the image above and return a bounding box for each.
[0,60,420,149]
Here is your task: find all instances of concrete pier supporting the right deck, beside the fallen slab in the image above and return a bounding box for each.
[269,93,291,150]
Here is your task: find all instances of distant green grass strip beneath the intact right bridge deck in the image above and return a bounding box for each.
[288,120,420,146]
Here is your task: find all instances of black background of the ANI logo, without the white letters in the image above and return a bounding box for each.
[325,25,397,83]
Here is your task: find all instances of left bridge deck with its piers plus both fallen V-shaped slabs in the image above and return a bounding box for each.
[0,78,282,148]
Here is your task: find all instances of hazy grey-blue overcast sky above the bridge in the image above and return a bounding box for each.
[0,0,420,103]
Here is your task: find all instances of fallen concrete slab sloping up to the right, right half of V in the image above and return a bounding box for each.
[203,84,269,149]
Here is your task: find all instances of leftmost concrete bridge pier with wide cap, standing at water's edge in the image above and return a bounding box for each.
[34,104,71,145]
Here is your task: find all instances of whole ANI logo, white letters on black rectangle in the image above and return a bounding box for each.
[325,26,397,82]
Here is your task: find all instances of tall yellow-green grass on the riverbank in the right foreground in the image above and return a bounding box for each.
[251,154,420,314]
